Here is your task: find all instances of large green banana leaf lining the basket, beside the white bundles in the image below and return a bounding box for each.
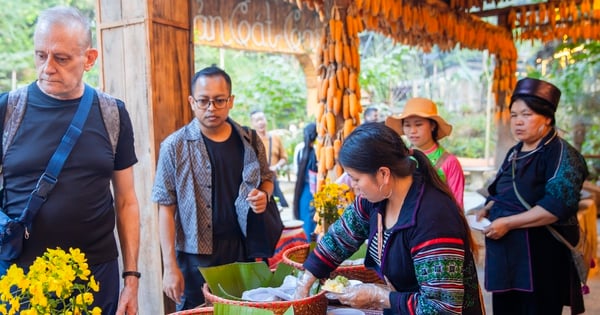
[198,262,294,301]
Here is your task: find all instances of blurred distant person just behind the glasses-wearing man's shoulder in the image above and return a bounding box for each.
[250,110,289,208]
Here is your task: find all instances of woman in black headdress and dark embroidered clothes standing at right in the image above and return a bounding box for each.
[477,78,588,315]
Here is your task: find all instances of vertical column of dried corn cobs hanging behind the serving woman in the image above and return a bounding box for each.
[316,4,364,191]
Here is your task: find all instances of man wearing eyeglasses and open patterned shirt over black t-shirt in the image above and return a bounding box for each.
[152,66,273,311]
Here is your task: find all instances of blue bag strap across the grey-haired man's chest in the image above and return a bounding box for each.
[19,84,94,227]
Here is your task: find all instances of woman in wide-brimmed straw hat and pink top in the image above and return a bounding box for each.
[385,97,465,207]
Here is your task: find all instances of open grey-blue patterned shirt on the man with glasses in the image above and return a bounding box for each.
[152,119,273,254]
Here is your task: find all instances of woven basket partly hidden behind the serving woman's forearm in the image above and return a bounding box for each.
[282,244,384,284]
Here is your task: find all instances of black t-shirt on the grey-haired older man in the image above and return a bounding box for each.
[4,83,137,266]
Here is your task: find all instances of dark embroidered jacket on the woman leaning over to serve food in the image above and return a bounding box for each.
[304,175,484,314]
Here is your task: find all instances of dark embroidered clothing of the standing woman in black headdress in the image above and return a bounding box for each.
[485,131,588,310]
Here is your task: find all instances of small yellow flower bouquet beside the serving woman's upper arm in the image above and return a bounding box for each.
[312,180,354,234]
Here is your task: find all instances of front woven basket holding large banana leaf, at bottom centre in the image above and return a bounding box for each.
[202,283,327,315]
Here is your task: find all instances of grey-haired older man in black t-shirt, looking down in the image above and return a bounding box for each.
[0,6,140,314]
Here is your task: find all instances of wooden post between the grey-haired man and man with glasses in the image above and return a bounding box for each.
[96,0,193,314]
